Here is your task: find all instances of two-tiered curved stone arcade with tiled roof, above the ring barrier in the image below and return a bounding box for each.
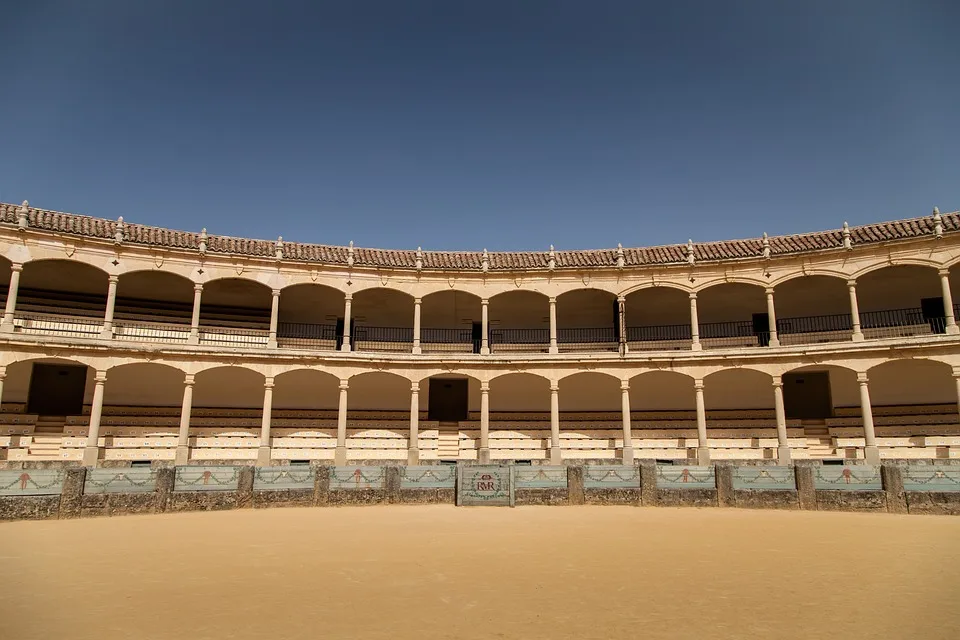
[0,203,960,466]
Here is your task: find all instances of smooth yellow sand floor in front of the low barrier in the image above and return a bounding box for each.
[0,506,960,640]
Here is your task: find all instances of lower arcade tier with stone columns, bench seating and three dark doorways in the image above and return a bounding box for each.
[0,354,960,466]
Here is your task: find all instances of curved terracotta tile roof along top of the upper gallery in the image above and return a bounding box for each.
[0,203,960,271]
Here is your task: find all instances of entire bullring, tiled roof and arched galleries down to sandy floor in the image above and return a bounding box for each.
[0,203,960,638]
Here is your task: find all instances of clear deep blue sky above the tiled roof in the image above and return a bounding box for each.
[0,0,960,250]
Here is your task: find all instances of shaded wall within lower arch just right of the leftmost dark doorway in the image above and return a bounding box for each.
[103,362,184,407]
